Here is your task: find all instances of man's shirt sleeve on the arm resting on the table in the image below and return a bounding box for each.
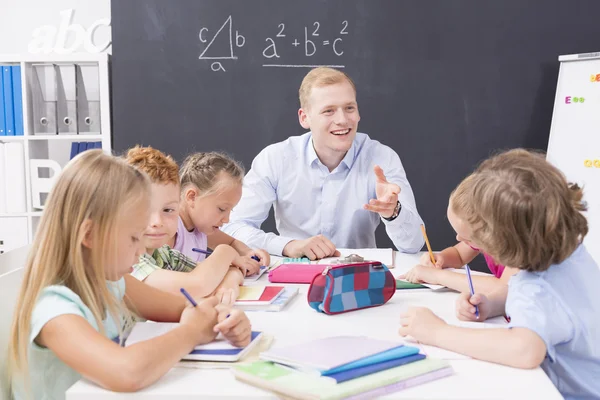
[223,146,293,255]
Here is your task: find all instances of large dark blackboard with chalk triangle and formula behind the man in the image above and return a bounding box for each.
[112,0,600,270]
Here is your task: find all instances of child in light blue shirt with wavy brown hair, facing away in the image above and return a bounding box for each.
[400,149,600,398]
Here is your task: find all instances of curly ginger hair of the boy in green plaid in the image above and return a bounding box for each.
[125,145,179,185]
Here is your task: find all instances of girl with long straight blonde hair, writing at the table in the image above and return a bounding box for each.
[8,150,250,399]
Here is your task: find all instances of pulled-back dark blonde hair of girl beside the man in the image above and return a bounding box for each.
[180,152,244,197]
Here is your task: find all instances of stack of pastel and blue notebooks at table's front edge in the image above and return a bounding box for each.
[232,336,453,400]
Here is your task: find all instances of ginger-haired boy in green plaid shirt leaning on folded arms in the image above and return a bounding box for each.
[126,146,245,304]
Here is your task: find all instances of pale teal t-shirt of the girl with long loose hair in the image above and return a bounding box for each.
[12,278,125,400]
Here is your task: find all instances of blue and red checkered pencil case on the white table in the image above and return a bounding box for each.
[307,261,396,314]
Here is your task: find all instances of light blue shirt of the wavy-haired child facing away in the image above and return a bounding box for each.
[508,245,600,399]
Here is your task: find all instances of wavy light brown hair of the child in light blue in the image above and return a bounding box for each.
[450,149,588,271]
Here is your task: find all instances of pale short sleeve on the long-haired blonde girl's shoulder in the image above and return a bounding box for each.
[29,286,88,346]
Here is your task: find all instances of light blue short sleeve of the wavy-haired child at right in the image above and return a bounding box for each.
[506,282,574,361]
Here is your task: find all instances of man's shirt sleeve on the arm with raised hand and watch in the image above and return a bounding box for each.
[378,145,425,253]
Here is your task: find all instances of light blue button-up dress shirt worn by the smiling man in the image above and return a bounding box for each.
[223,132,424,255]
